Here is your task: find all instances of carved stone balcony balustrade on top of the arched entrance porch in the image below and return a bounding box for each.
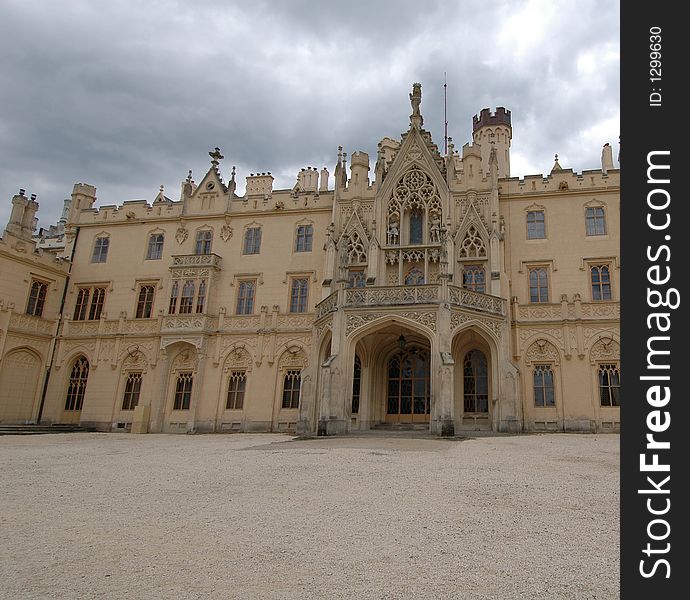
[315,284,506,321]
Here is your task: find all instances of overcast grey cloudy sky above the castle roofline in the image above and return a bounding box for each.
[0,0,620,231]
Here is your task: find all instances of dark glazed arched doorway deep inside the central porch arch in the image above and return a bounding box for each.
[386,345,431,423]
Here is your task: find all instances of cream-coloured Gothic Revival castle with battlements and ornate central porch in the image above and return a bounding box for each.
[0,84,620,435]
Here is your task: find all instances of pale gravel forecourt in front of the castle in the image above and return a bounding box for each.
[0,433,619,600]
